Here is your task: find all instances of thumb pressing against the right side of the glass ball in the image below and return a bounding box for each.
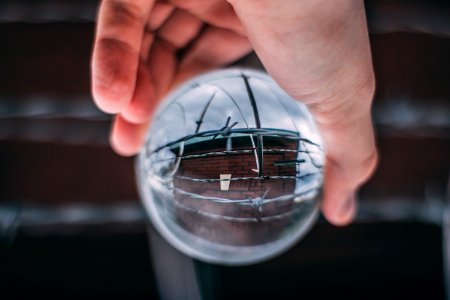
[319,95,377,225]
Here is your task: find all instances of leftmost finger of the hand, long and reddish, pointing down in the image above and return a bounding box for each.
[91,0,155,113]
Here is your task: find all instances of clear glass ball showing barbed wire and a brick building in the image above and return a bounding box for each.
[136,69,324,265]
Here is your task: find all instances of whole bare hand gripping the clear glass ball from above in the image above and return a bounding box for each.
[92,0,377,225]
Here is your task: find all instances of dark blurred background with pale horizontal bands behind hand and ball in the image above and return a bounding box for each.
[0,0,450,299]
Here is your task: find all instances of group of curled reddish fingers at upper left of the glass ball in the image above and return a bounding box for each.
[98,0,251,156]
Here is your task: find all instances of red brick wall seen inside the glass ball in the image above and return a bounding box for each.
[174,138,304,245]
